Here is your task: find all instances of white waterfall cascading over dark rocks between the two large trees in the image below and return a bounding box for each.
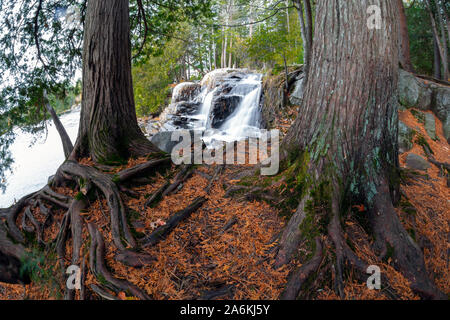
[150,69,262,147]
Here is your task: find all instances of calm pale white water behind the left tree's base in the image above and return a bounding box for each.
[0,111,80,208]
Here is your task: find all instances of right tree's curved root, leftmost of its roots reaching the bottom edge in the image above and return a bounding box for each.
[280,238,323,300]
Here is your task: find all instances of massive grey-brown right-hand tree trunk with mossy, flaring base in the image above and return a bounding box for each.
[276,0,442,298]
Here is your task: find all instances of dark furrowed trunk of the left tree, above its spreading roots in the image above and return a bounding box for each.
[72,0,156,162]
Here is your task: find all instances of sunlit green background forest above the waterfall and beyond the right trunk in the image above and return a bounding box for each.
[133,0,450,116]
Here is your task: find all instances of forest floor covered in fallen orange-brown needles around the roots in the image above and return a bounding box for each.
[0,110,450,300]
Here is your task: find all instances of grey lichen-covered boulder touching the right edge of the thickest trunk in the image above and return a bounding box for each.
[398,69,433,110]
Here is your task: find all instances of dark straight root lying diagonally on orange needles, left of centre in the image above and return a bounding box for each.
[142,197,206,247]
